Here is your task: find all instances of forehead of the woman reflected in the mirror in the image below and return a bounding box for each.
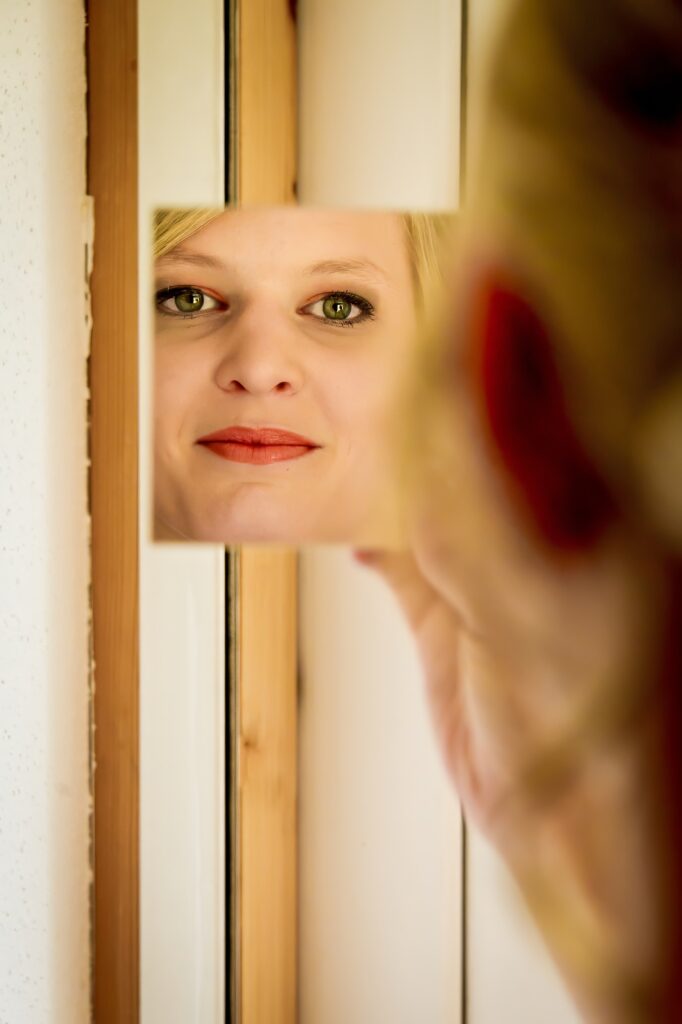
[159,207,411,284]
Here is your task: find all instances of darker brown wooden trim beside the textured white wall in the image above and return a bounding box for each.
[88,0,139,1024]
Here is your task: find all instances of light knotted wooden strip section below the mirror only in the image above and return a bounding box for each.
[238,548,297,1024]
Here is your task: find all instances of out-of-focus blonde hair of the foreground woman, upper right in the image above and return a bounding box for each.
[471,0,682,550]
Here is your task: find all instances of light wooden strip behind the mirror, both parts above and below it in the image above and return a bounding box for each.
[233,0,298,1024]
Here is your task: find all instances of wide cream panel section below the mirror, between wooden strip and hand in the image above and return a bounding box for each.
[299,548,462,1024]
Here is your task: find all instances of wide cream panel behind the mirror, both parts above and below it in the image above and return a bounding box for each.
[299,0,462,1024]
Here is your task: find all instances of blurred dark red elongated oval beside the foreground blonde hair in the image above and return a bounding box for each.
[473,280,615,552]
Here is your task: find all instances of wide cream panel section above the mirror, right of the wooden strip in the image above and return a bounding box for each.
[298,0,461,210]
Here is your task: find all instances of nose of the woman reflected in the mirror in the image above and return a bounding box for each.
[214,306,304,396]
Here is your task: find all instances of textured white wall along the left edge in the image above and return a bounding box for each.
[0,0,89,1024]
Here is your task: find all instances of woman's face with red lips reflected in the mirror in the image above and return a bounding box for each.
[155,208,415,543]
